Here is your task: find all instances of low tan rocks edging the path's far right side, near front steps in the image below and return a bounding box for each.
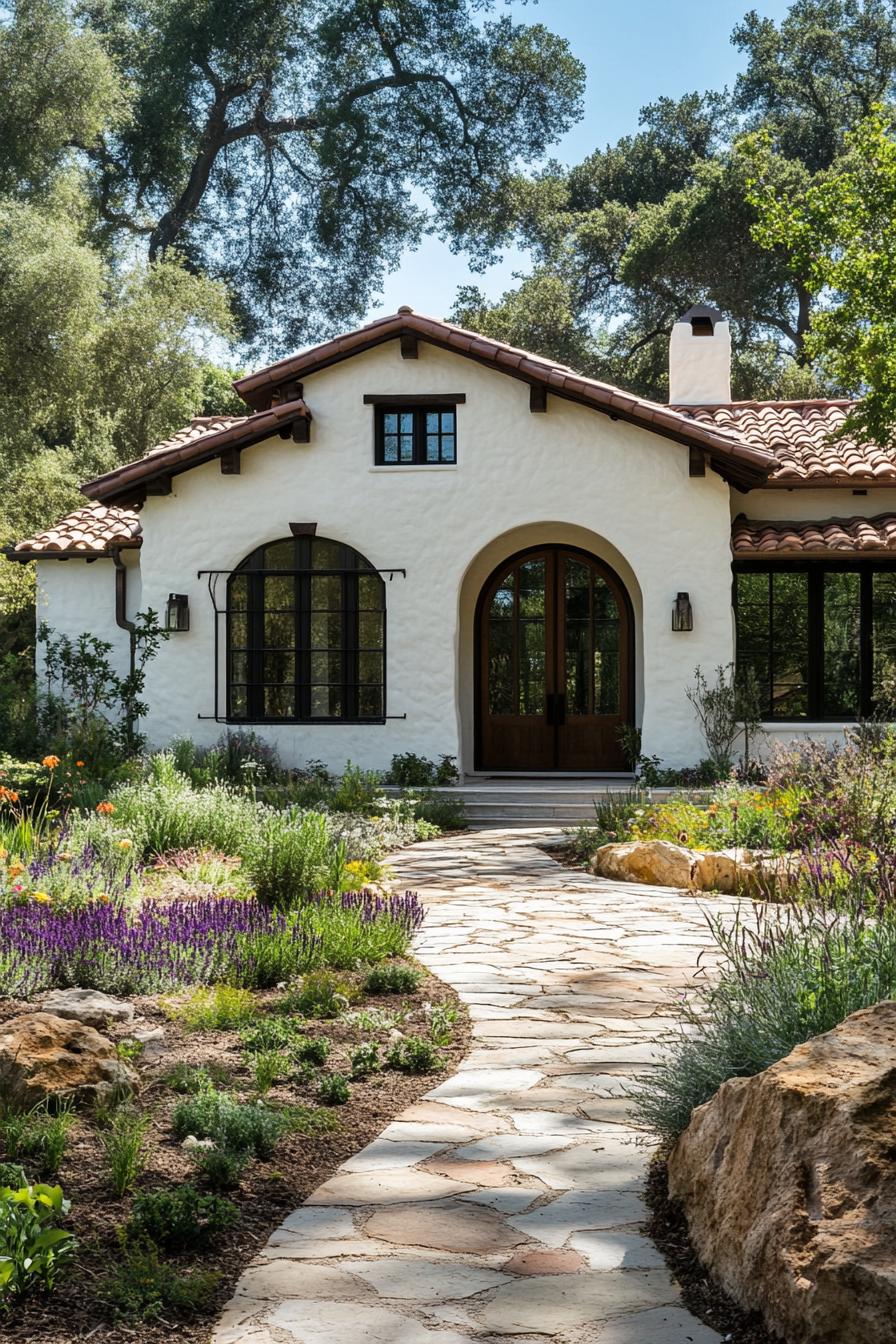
[591,840,801,895]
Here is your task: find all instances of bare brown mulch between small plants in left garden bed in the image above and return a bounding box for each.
[0,968,469,1344]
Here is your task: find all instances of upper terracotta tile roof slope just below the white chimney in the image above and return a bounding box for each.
[681,402,896,487]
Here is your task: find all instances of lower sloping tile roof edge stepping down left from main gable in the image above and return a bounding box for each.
[81,396,312,503]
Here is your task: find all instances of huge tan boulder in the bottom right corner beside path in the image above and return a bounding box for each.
[669,1001,896,1344]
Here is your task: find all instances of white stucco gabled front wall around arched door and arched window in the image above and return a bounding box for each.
[118,341,732,770]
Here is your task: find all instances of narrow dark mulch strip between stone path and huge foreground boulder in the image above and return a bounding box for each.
[645,1157,786,1344]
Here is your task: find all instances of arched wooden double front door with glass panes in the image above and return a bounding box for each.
[477,546,633,773]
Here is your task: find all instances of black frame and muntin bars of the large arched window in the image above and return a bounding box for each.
[224,535,387,726]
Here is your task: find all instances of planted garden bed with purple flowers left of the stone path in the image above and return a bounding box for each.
[0,735,467,1344]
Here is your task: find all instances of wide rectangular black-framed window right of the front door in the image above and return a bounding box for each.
[735,562,896,722]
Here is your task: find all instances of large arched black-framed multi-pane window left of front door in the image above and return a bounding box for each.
[227,536,386,723]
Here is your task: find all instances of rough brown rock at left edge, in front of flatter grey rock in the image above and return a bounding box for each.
[0,1012,137,1109]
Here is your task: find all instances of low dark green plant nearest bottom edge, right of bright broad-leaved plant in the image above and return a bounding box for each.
[99,1238,220,1321]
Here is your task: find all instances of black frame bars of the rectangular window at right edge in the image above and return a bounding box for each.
[731,559,896,723]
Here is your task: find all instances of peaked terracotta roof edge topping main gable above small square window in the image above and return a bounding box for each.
[234,308,775,485]
